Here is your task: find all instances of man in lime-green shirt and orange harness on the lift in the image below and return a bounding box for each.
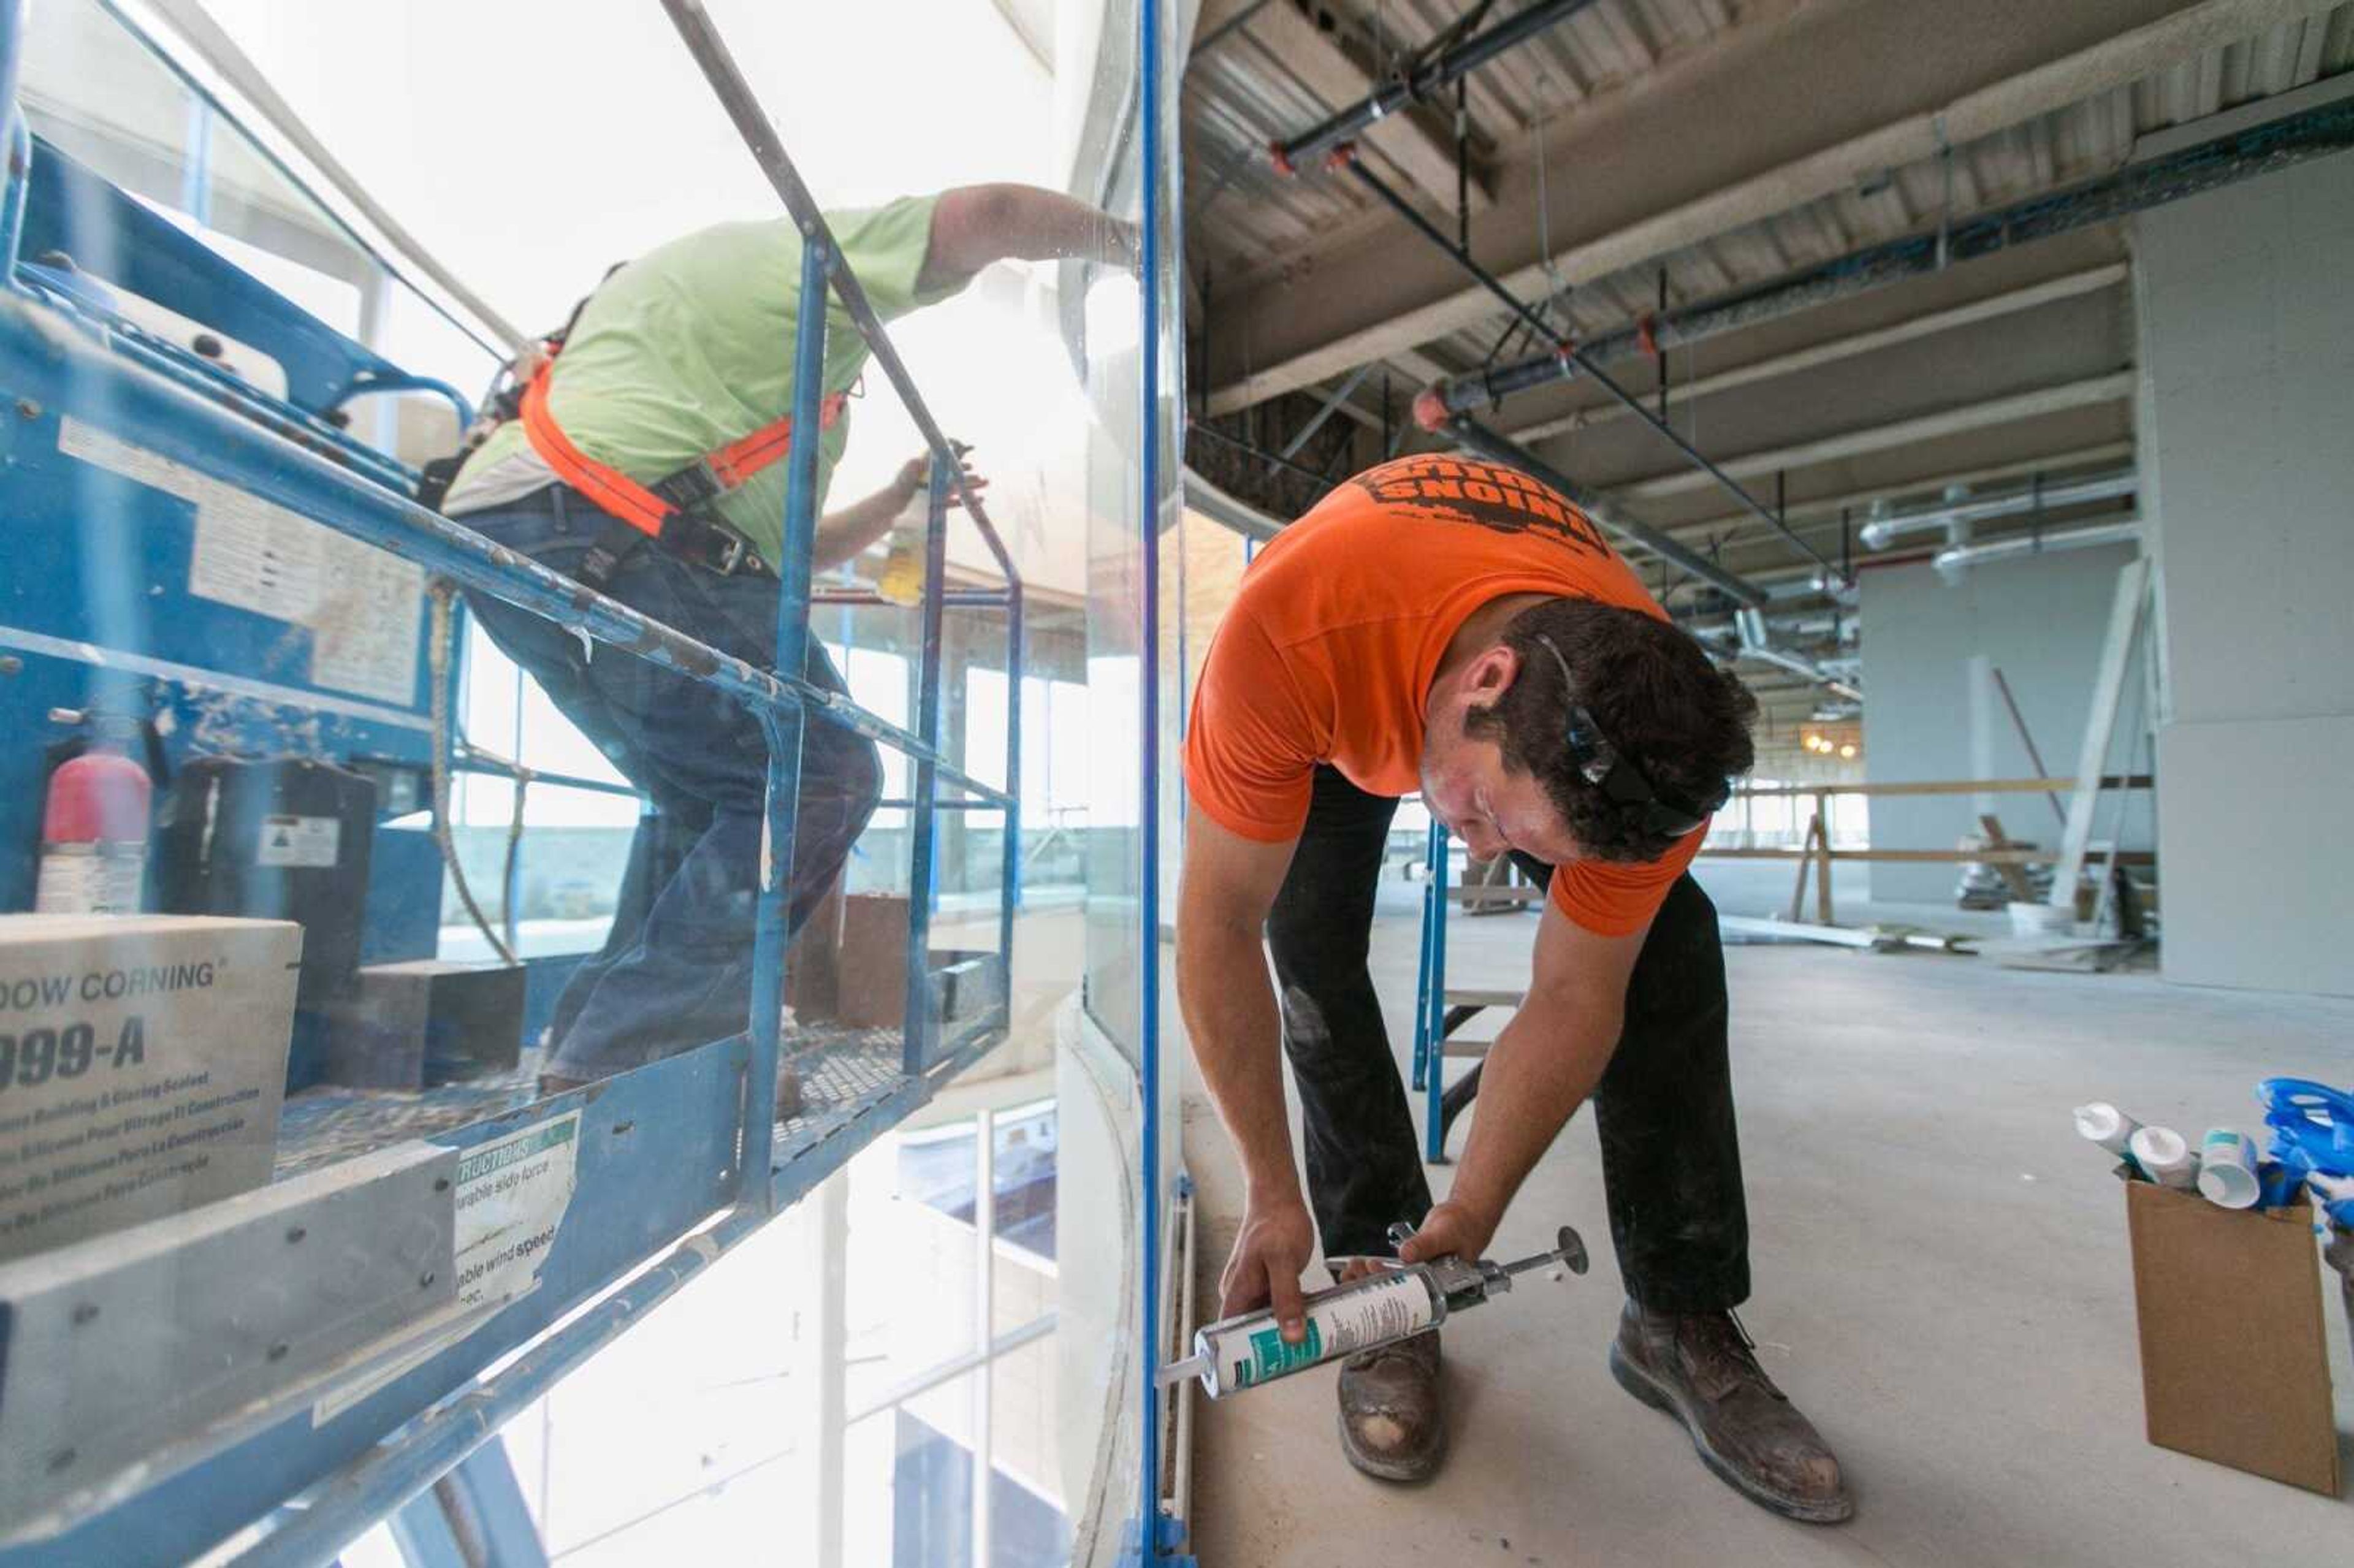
[443,184,1137,1090]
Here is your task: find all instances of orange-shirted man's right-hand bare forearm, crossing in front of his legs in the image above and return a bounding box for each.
[1401,899,1650,1262]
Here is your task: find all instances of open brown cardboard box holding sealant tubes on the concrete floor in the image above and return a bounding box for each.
[2126,1182,2337,1498]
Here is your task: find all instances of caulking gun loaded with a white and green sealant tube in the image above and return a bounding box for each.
[1160,1222,1586,1398]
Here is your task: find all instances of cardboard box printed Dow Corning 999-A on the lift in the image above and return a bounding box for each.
[0,913,302,1257]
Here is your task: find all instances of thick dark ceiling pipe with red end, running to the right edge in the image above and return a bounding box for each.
[1415,101,2354,428]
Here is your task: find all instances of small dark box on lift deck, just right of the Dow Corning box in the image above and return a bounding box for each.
[318,958,525,1090]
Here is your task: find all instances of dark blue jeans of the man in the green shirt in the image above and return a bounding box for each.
[459,485,883,1078]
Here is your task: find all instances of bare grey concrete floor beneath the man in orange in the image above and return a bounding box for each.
[1186,866,2354,1568]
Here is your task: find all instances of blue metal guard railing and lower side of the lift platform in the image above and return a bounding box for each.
[0,0,1024,1568]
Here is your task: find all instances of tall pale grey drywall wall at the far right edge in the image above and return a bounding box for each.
[2133,153,2354,994]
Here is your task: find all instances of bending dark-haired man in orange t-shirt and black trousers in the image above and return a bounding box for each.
[1177,457,1850,1521]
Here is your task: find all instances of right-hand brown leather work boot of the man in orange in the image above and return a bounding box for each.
[1610,1300,1855,1523]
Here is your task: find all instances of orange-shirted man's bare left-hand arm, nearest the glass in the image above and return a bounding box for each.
[1177,805,1316,1339]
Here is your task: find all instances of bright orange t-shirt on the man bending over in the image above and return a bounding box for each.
[1184,454,1707,937]
